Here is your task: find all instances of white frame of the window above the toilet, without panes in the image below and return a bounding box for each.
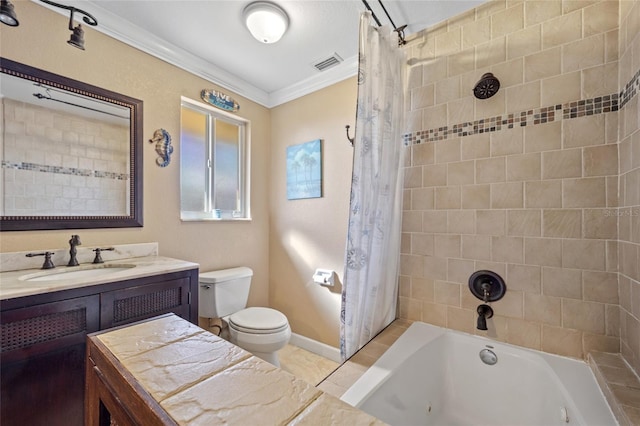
[180,96,251,222]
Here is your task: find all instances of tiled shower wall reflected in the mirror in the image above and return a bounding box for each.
[0,98,130,216]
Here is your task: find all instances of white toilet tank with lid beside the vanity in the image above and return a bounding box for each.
[198,267,253,318]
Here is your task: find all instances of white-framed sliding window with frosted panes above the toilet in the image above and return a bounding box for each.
[180,98,251,220]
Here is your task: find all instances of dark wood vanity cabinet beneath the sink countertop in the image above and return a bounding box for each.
[0,269,198,426]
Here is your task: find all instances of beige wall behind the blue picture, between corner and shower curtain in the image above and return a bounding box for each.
[269,77,357,347]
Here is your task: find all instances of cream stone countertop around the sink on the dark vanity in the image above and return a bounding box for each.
[0,256,199,300]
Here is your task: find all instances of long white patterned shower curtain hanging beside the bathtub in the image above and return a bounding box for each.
[340,12,405,360]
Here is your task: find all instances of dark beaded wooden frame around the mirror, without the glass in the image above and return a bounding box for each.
[0,58,143,231]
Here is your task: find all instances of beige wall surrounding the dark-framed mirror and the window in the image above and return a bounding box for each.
[0,1,271,305]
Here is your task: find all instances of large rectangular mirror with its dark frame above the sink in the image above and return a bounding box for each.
[0,58,143,231]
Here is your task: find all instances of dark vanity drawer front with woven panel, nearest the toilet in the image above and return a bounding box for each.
[100,278,191,330]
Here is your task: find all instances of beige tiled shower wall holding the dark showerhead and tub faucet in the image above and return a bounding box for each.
[399,0,640,369]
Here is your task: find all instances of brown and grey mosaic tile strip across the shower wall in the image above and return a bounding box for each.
[403,70,640,145]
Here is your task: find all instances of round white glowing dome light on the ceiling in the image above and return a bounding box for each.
[242,1,289,44]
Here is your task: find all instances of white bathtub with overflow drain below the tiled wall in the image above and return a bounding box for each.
[341,322,618,426]
